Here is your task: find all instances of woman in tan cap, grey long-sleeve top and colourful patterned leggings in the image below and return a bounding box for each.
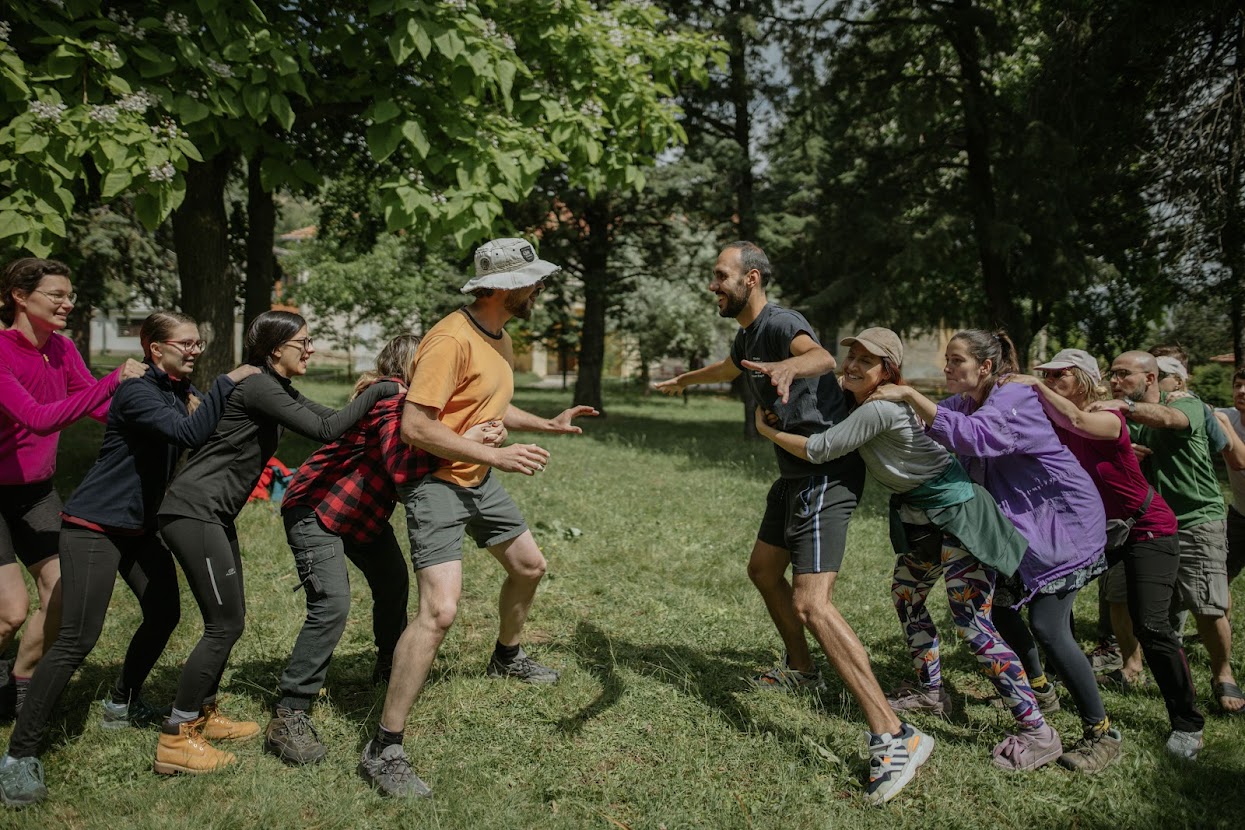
[757,327,1061,770]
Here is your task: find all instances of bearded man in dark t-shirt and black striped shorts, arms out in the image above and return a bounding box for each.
[655,241,934,803]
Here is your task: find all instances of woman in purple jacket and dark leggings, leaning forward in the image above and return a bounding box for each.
[875,329,1121,773]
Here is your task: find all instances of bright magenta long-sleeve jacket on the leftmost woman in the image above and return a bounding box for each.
[0,329,121,485]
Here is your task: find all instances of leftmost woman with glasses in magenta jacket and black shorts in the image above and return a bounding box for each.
[0,258,143,717]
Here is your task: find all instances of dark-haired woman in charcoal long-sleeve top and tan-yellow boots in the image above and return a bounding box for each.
[153,311,398,774]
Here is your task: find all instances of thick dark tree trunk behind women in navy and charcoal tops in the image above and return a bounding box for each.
[173,154,238,385]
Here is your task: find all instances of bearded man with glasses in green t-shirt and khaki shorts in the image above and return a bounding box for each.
[1089,351,1245,714]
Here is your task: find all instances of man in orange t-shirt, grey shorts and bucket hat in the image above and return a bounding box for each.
[359,239,598,796]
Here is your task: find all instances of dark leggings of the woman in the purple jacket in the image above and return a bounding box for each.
[994,590,1107,724]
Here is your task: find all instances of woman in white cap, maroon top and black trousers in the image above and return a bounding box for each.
[1003,348,1203,760]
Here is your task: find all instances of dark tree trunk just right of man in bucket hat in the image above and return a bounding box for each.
[573,194,613,414]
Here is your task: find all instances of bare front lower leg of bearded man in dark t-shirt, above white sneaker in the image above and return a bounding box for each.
[793,571,903,734]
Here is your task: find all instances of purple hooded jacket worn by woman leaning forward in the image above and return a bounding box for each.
[926,383,1107,605]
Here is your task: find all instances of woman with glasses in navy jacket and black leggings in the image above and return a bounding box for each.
[0,311,259,805]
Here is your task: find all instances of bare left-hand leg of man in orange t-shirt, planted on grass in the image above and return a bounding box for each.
[381,560,463,732]
